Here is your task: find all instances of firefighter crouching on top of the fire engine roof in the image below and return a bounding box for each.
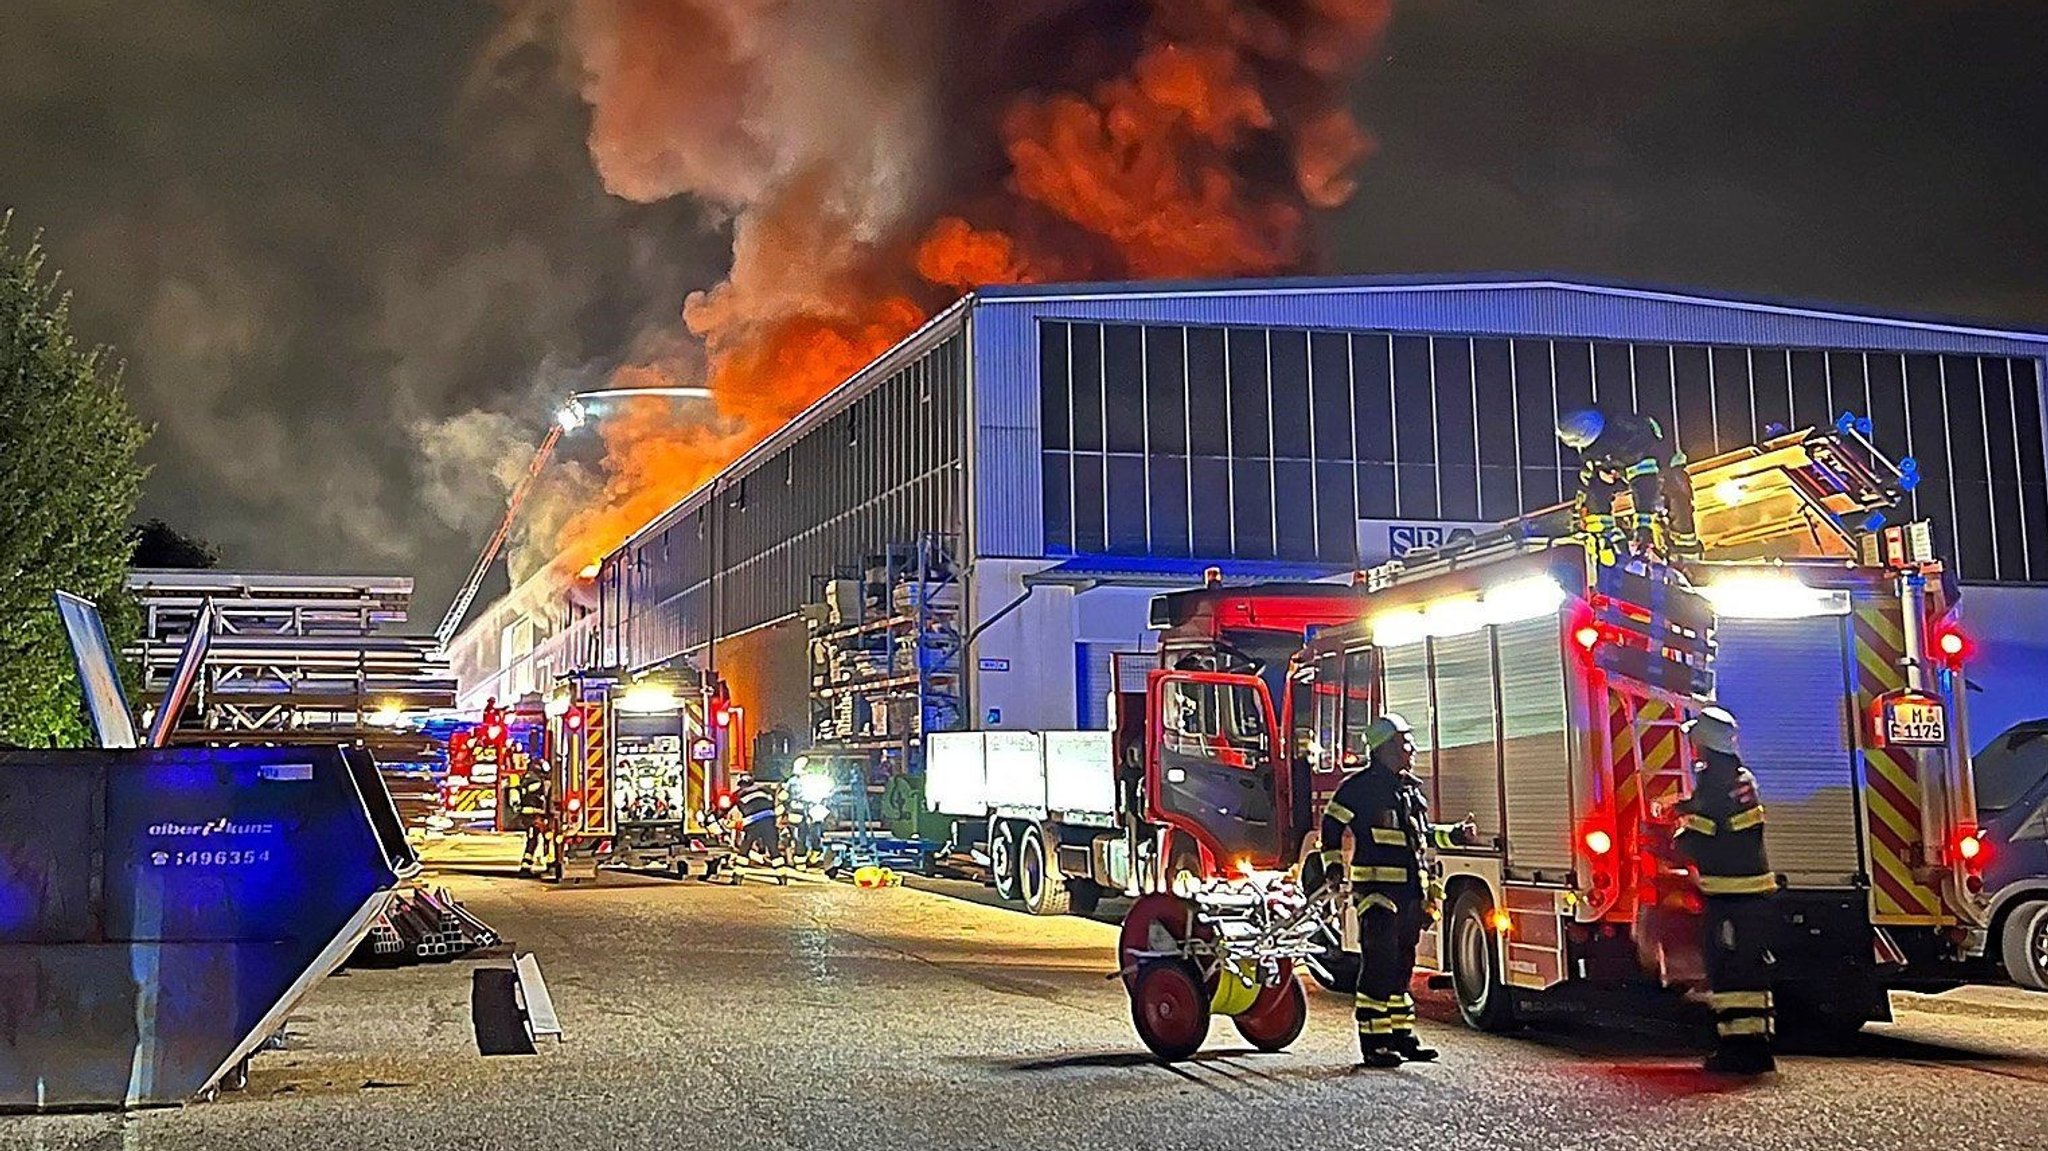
[1556,408,1700,559]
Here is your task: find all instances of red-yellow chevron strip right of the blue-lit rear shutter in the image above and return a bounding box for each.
[1855,596,1944,924]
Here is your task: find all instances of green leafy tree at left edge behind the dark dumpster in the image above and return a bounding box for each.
[0,217,147,745]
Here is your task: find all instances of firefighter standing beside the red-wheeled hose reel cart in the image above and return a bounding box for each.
[1323,713,1479,1067]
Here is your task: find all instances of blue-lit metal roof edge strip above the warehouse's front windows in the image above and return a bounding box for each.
[975,274,2048,356]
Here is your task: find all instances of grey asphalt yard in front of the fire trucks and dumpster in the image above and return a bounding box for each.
[12,877,2048,1151]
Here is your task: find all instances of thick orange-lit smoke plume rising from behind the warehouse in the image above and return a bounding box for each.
[516,0,1391,569]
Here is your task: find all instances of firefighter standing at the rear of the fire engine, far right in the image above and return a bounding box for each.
[1673,707,1778,1075]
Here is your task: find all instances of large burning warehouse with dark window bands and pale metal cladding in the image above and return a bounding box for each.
[464,279,2048,739]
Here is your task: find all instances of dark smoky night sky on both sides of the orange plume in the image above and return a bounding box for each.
[0,0,2048,616]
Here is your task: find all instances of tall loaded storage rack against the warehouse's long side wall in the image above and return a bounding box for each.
[807,535,963,862]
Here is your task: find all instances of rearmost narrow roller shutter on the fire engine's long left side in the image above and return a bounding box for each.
[1497,616,1573,864]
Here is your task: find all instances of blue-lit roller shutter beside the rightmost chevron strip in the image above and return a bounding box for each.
[1714,616,1864,887]
